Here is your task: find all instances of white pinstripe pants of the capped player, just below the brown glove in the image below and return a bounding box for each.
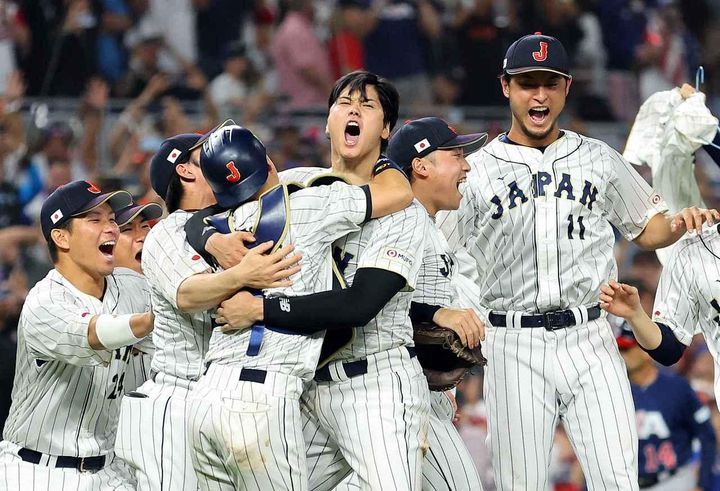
[335,392,483,491]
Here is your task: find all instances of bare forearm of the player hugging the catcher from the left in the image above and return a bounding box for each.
[177,270,244,313]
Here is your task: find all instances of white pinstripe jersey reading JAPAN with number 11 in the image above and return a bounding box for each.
[437,131,667,312]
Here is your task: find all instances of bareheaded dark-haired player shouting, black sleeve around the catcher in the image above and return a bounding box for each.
[211,72,429,490]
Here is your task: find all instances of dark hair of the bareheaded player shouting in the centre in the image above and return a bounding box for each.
[328,70,400,151]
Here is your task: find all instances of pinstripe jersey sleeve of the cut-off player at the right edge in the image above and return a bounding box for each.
[653,236,701,345]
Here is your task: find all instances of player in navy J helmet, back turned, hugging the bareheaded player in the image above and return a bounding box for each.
[183,126,413,490]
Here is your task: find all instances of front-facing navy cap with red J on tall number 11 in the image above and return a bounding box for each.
[503,32,570,78]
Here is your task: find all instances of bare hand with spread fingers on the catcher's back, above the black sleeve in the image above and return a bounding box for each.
[232,242,302,290]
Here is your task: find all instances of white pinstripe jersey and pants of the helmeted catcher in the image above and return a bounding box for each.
[188,183,367,490]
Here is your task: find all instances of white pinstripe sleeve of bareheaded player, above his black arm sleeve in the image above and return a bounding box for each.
[357,203,428,291]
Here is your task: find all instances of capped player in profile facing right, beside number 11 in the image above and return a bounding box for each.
[387,117,487,491]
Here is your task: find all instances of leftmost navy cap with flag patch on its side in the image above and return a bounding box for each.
[40,181,132,241]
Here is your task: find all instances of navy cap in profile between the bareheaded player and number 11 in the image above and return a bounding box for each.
[386,117,487,173]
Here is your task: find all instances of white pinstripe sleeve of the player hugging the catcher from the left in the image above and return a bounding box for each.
[142,212,212,310]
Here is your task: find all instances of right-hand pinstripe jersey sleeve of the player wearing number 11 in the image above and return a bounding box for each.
[603,150,667,240]
